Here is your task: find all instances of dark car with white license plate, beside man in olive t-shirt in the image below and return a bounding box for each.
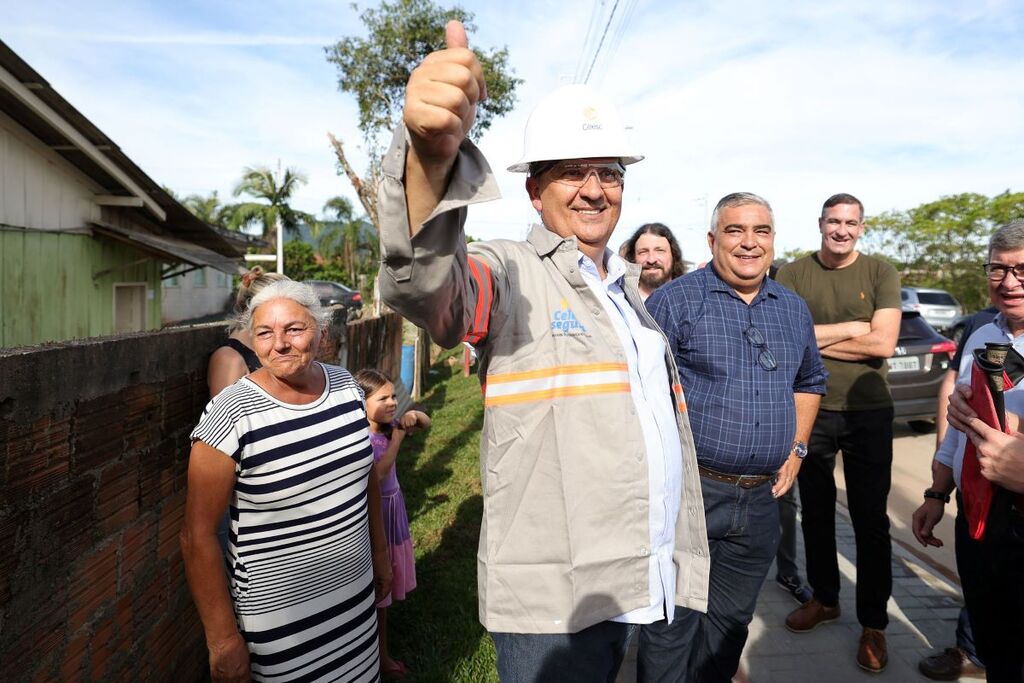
[888,310,956,433]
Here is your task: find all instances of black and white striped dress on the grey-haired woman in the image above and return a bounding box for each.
[191,364,379,683]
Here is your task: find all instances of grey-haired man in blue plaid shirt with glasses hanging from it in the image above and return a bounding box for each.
[647,193,825,681]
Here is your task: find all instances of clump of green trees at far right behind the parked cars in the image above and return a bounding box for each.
[864,189,1024,310]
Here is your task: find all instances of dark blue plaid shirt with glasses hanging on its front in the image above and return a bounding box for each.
[647,263,827,474]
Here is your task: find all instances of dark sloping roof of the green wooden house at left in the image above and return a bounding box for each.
[0,41,252,260]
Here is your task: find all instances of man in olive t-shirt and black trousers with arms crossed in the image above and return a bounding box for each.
[777,195,901,672]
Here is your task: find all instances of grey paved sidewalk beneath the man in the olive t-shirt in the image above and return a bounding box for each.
[617,506,982,683]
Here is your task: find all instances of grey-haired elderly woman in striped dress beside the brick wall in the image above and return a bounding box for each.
[181,281,390,681]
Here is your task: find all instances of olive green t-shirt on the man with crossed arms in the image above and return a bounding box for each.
[776,254,902,411]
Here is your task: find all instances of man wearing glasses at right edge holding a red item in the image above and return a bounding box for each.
[913,221,1024,683]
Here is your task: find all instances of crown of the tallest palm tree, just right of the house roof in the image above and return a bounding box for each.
[229,166,319,242]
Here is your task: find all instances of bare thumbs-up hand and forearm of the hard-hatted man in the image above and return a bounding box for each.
[402,20,486,236]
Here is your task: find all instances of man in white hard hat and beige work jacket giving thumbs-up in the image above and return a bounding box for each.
[379,22,710,681]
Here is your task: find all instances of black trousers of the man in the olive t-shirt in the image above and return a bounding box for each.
[799,408,893,629]
